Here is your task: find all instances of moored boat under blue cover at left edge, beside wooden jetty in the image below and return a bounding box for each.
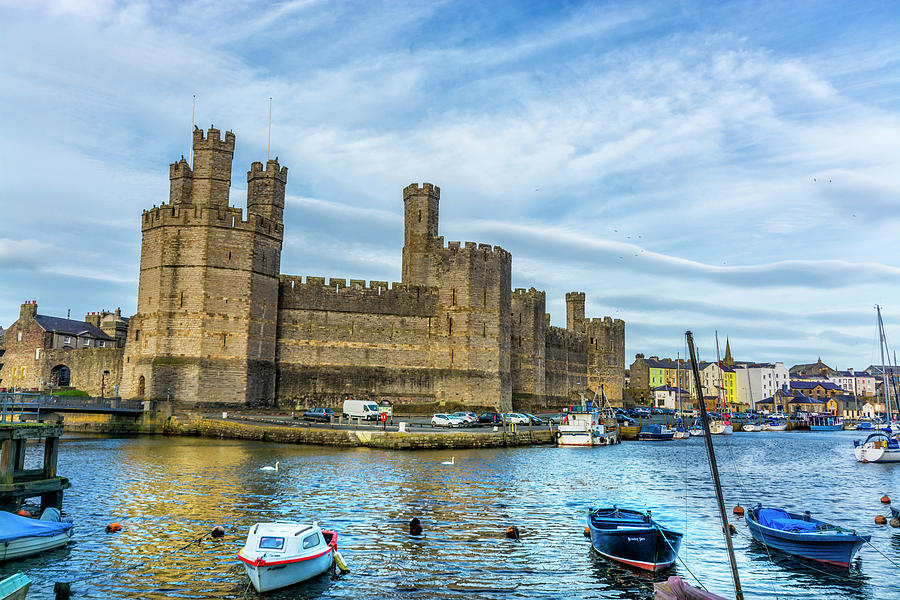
[0,507,72,561]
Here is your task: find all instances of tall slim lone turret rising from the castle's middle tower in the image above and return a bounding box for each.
[403,183,443,285]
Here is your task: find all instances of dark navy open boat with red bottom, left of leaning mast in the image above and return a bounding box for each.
[588,506,682,571]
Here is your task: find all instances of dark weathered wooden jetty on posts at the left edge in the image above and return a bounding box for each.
[0,421,71,512]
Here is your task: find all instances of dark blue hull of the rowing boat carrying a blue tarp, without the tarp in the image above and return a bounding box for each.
[746,509,871,568]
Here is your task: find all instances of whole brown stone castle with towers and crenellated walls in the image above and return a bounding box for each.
[0,128,625,410]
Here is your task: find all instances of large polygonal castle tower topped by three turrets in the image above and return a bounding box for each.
[121,128,287,403]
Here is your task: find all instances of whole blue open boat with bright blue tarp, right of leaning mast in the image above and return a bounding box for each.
[746,504,872,567]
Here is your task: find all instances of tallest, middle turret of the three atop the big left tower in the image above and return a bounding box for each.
[191,127,234,207]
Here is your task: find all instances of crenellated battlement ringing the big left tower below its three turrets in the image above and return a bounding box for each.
[141,204,284,239]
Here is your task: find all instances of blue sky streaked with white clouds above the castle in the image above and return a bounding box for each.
[0,0,900,368]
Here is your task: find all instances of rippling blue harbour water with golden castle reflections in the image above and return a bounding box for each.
[7,432,900,600]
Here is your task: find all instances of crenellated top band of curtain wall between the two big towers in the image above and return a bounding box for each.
[278,275,438,317]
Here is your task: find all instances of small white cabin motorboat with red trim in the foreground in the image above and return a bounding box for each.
[238,522,337,592]
